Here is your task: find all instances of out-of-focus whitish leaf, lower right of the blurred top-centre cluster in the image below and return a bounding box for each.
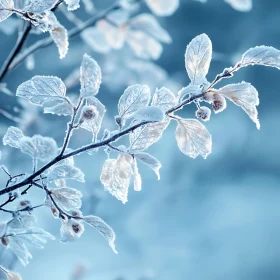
[126,30,163,60]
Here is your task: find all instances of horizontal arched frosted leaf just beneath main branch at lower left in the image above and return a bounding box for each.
[48,164,85,182]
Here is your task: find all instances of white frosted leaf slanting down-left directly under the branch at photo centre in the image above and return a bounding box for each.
[129,119,169,152]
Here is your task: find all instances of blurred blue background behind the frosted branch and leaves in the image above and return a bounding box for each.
[0,0,280,280]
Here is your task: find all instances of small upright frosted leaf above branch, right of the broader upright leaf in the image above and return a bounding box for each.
[152,87,177,112]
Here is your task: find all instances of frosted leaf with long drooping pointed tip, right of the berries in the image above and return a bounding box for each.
[217,82,260,129]
